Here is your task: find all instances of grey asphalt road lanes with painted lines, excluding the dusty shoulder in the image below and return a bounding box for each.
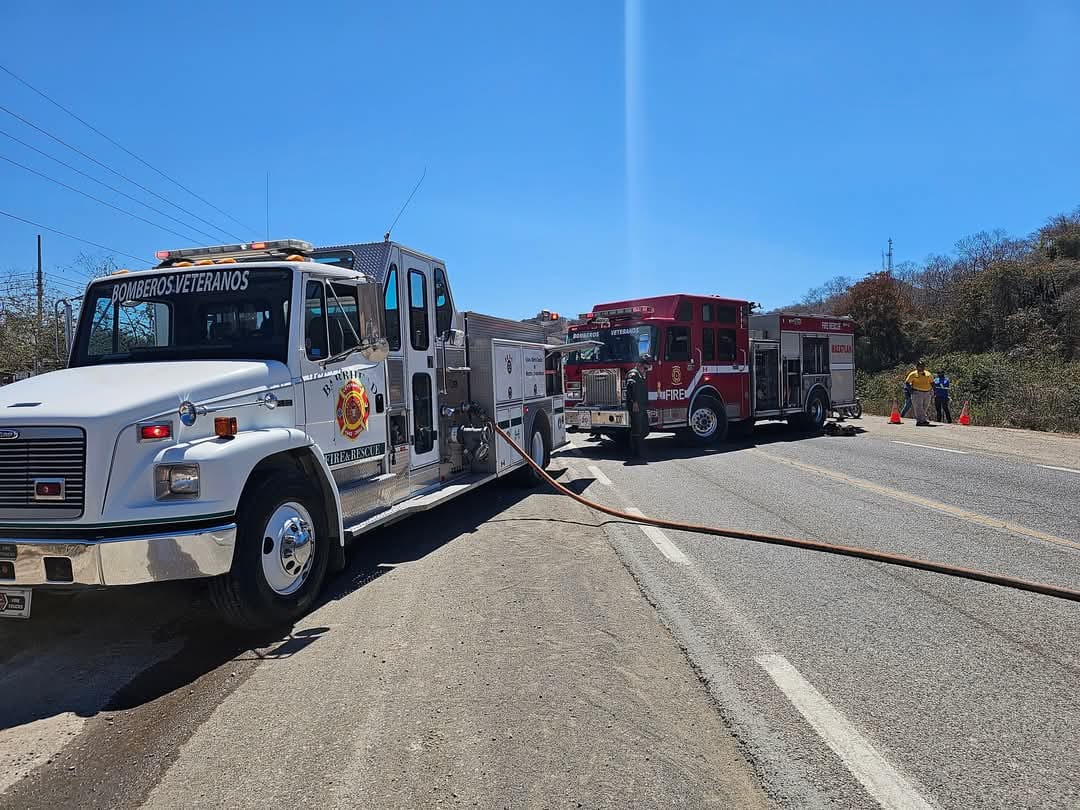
[559,419,1080,808]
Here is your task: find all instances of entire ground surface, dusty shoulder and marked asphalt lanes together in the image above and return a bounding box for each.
[0,418,1080,808]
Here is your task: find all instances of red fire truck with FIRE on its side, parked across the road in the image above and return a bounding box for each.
[564,295,855,444]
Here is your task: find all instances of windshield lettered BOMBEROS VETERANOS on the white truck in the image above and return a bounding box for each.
[71,265,292,366]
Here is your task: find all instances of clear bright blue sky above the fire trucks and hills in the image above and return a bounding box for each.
[0,0,1080,318]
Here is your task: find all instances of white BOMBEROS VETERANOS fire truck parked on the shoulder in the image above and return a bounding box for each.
[0,240,566,626]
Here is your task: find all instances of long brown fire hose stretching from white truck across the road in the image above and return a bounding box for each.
[491,422,1080,602]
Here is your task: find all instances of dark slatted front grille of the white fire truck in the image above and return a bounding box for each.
[0,426,86,519]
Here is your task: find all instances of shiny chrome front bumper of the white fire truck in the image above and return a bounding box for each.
[0,523,237,588]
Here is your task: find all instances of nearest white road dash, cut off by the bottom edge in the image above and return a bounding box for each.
[754,654,932,810]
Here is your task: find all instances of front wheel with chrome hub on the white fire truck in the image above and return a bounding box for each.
[210,473,332,630]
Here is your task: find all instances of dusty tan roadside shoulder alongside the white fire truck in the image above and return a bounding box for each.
[0,473,766,808]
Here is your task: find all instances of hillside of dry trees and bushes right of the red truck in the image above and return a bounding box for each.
[781,208,1080,432]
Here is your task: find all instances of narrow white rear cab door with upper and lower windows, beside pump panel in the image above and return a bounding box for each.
[402,257,438,470]
